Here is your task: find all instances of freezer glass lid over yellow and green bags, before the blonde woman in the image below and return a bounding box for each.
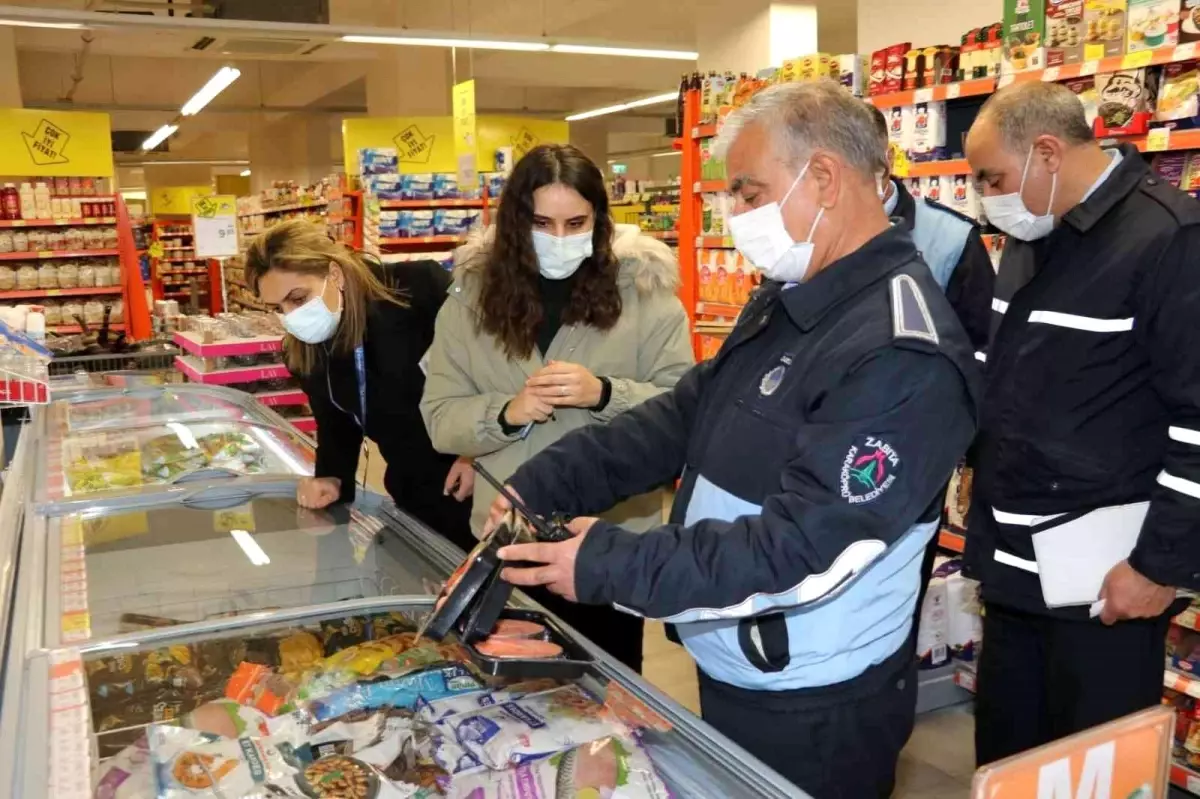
[40,412,313,501]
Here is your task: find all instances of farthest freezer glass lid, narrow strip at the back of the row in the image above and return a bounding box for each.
[50,386,256,435]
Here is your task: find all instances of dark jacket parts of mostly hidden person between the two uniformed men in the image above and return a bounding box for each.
[892,180,996,350]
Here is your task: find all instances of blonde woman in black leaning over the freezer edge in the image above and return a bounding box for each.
[245,220,474,548]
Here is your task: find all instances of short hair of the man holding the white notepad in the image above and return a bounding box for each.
[979,80,1096,154]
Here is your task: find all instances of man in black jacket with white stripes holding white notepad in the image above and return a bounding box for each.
[966,82,1200,764]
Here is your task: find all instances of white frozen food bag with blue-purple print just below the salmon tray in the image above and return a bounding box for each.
[443,685,626,769]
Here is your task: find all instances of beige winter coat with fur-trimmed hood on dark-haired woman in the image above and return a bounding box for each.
[421,224,694,535]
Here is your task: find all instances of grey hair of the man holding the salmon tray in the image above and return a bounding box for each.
[714,78,888,180]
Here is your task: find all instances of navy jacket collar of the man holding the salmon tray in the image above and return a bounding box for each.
[779,220,917,331]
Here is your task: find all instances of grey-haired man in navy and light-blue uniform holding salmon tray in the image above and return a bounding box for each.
[493,80,976,799]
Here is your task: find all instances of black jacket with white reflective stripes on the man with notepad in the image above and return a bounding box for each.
[966,146,1200,618]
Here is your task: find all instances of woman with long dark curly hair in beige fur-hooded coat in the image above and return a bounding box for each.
[421,145,692,669]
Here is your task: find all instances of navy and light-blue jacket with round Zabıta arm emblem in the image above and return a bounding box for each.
[511,228,976,690]
